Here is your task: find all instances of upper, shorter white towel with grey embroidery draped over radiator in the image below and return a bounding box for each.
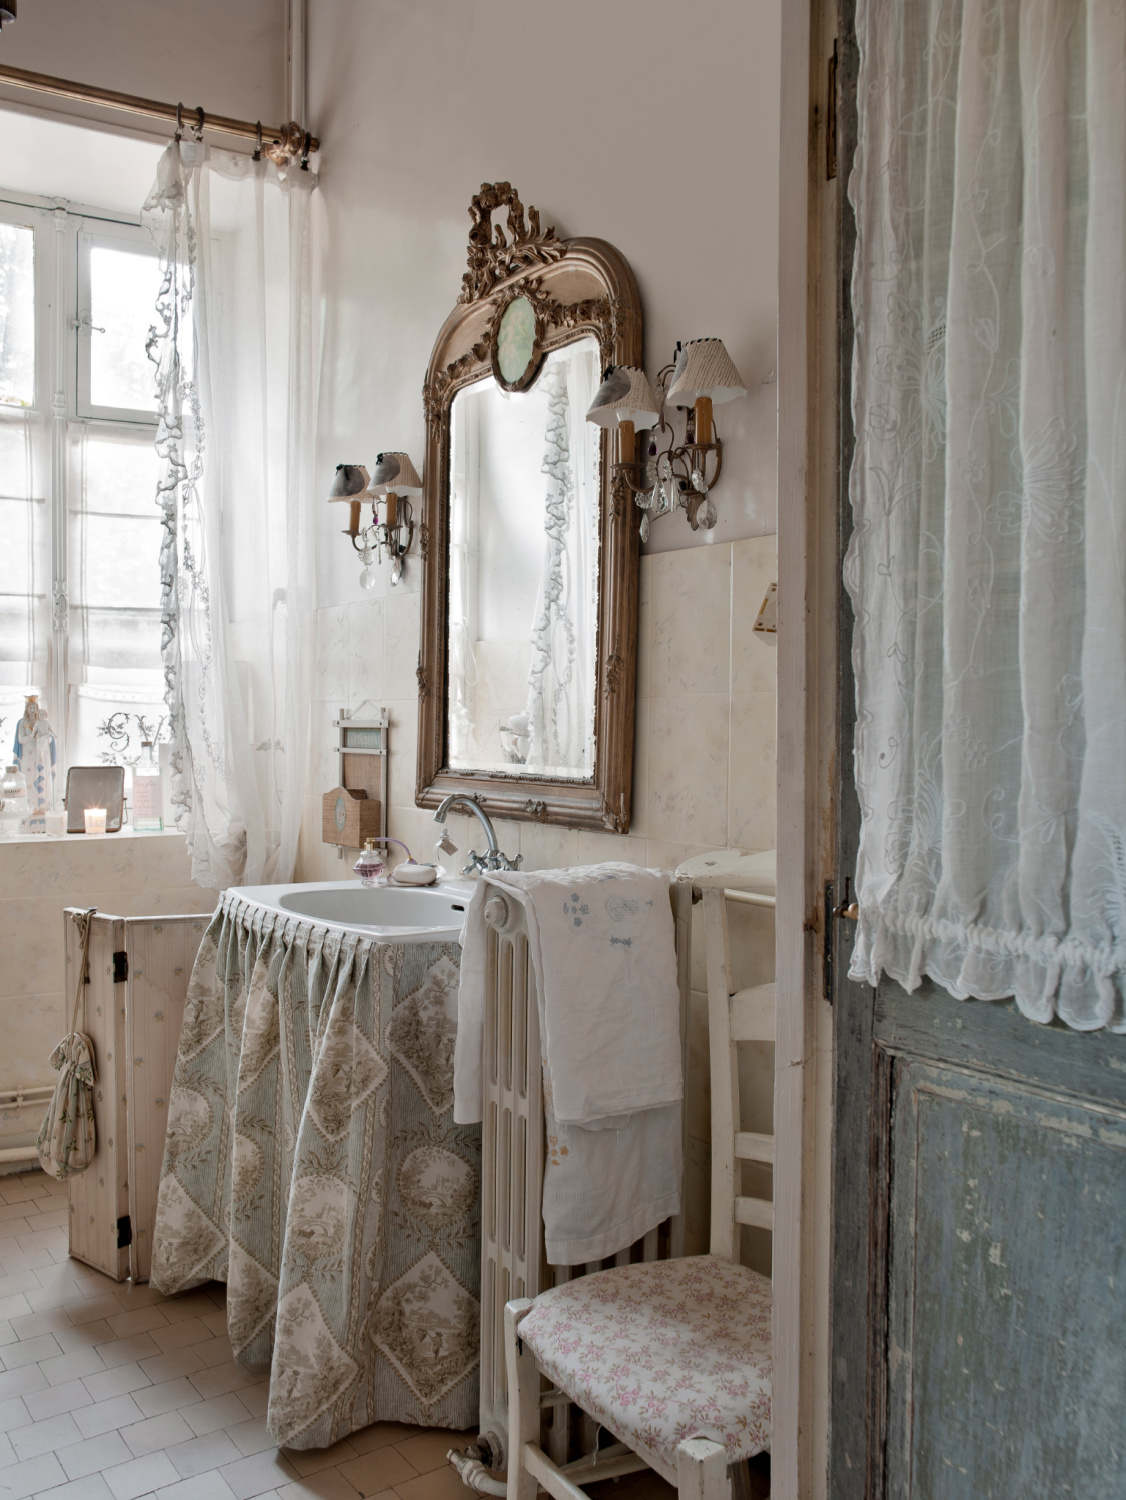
[454,864,684,1125]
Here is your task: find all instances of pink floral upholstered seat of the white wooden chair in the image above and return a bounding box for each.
[519,1256,772,1470]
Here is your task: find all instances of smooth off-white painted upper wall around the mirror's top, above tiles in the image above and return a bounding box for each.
[309,0,781,605]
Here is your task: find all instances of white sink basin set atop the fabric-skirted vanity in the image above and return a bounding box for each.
[238,881,474,942]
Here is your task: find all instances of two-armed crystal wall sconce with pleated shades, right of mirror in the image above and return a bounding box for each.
[586,339,747,542]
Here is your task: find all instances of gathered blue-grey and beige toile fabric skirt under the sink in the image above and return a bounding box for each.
[151,891,481,1448]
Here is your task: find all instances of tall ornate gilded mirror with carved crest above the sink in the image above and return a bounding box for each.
[415,183,642,833]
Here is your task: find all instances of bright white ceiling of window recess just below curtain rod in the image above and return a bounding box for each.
[0,110,163,215]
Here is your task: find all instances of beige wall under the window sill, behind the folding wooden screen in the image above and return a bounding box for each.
[0,831,217,1146]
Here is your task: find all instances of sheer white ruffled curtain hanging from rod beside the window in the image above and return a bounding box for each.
[144,144,318,888]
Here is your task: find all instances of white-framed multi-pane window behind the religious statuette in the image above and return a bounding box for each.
[0,191,165,786]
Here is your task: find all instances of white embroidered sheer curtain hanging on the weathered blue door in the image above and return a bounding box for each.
[846,0,1126,1031]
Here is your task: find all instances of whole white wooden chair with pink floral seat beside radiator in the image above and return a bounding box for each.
[504,855,774,1500]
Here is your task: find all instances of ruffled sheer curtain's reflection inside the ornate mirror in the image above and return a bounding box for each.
[526,354,598,774]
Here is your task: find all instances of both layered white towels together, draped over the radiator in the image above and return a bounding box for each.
[454,864,684,1266]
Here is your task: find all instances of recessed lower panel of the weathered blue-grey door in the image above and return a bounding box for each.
[886,1056,1126,1500]
